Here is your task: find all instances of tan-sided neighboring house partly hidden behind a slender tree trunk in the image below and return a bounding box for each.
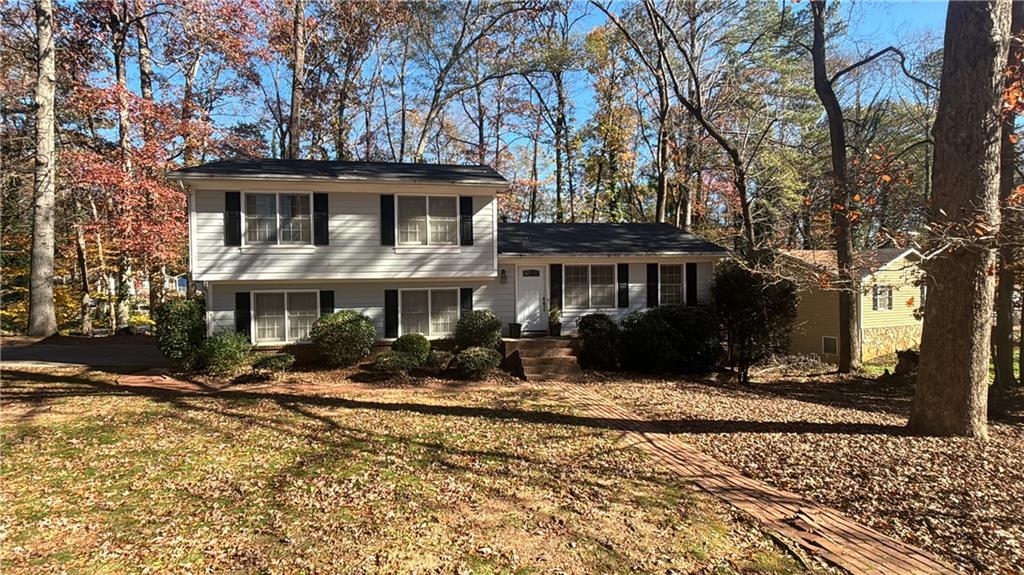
[784,249,927,362]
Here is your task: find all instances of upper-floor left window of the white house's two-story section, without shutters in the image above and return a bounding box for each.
[246,193,312,246]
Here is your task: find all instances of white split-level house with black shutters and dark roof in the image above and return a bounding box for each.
[168,160,726,346]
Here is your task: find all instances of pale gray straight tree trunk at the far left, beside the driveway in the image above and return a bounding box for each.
[29,0,57,337]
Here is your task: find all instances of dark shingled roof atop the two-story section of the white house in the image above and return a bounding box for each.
[168,160,508,185]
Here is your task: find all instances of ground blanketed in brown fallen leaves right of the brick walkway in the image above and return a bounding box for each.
[587,373,1024,573]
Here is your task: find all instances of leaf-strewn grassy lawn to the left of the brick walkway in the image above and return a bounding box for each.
[0,369,800,573]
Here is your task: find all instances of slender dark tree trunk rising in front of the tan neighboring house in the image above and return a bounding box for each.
[811,0,860,373]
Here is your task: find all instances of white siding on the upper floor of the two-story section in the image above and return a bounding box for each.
[191,190,498,285]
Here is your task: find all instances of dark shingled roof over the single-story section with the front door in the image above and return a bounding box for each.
[498,223,726,256]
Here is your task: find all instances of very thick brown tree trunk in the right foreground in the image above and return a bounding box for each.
[908,0,1011,438]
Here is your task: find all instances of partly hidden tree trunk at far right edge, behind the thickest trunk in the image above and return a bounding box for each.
[988,0,1024,401]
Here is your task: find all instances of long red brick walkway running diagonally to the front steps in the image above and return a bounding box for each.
[559,384,957,575]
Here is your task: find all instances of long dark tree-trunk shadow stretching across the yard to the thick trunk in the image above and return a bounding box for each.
[5,370,907,435]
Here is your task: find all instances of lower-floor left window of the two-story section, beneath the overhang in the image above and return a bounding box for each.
[253,292,319,344]
